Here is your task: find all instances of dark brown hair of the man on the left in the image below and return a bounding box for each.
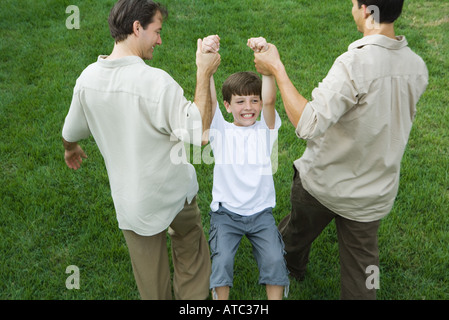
[108,0,168,42]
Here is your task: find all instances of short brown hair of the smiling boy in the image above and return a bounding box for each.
[221,71,262,103]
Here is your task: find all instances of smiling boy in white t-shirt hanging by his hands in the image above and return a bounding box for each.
[203,36,289,300]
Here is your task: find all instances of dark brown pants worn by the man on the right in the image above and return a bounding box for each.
[279,168,380,299]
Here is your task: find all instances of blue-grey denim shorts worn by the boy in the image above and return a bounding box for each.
[209,205,289,290]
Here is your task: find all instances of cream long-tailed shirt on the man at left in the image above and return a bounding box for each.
[63,56,202,236]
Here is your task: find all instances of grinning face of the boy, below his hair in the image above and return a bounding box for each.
[224,95,263,127]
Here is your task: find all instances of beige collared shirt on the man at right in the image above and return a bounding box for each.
[295,35,428,222]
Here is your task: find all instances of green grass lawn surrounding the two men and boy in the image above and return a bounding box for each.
[0,0,449,300]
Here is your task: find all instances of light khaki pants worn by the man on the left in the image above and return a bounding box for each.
[123,198,211,300]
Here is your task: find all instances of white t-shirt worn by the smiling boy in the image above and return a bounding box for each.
[209,105,281,216]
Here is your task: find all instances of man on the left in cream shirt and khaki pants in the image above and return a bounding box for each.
[62,0,220,299]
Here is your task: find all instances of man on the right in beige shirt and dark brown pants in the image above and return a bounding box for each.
[255,0,428,299]
